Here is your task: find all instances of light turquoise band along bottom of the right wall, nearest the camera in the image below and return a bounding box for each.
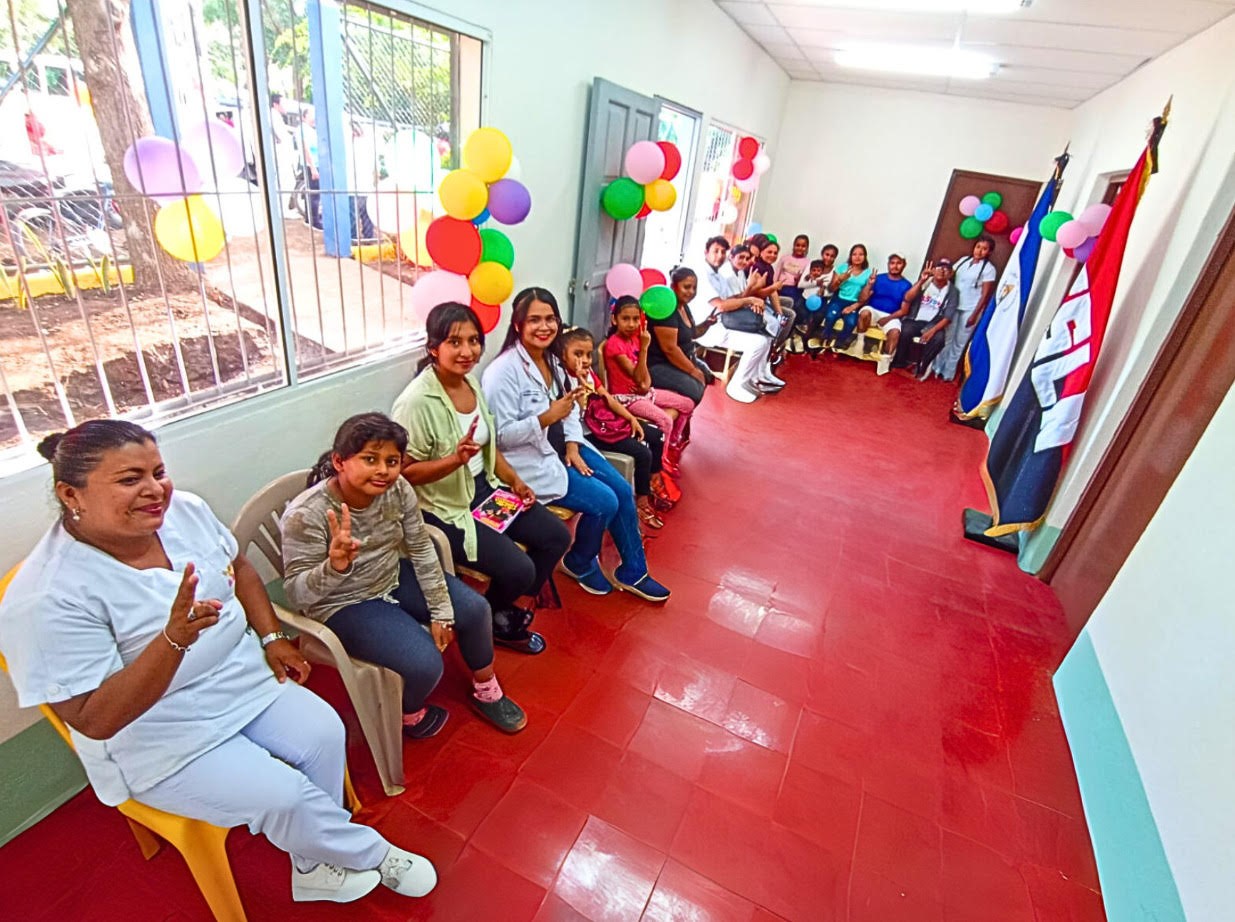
[1055,631,1186,922]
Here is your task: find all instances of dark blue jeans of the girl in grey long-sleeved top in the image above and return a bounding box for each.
[326,560,493,713]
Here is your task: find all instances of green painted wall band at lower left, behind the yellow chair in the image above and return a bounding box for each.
[0,721,86,845]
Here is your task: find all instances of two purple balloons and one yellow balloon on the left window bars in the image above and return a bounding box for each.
[125,120,245,263]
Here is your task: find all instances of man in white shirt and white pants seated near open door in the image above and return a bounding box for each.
[690,237,777,404]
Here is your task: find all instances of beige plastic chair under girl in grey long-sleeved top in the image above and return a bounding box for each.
[232,470,453,797]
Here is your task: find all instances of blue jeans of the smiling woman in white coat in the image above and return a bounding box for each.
[553,444,647,585]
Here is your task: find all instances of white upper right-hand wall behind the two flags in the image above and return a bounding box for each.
[1013,16,1235,559]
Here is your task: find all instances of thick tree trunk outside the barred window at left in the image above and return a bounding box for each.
[65,0,198,295]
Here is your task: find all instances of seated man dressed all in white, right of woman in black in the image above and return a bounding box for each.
[691,237,784,404]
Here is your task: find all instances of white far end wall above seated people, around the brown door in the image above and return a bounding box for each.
[755,83,1072,272]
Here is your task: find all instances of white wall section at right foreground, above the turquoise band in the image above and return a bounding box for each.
[1087,390,1235,922]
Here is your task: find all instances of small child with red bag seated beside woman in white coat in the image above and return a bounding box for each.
[558,327,664,528]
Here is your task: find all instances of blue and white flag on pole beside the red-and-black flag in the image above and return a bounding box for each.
[953,151,1068,420]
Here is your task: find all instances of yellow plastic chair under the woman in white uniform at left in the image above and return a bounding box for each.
[0,564,361,922]
